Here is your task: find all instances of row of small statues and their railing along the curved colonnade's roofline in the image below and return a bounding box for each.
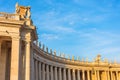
[34,42,117,65]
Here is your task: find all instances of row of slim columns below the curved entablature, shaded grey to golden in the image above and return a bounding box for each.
[34,59,120,80]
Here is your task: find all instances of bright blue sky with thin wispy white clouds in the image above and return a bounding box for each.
[0,0,120,62]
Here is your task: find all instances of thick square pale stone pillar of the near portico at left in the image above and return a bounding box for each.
[10,37,21,80]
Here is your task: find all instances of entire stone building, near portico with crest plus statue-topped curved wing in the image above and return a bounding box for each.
[0,4,120,80]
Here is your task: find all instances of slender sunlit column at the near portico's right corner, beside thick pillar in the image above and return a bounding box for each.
[25,37,34,80]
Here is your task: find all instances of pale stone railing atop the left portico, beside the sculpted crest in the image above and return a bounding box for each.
[0,12,20,20]
